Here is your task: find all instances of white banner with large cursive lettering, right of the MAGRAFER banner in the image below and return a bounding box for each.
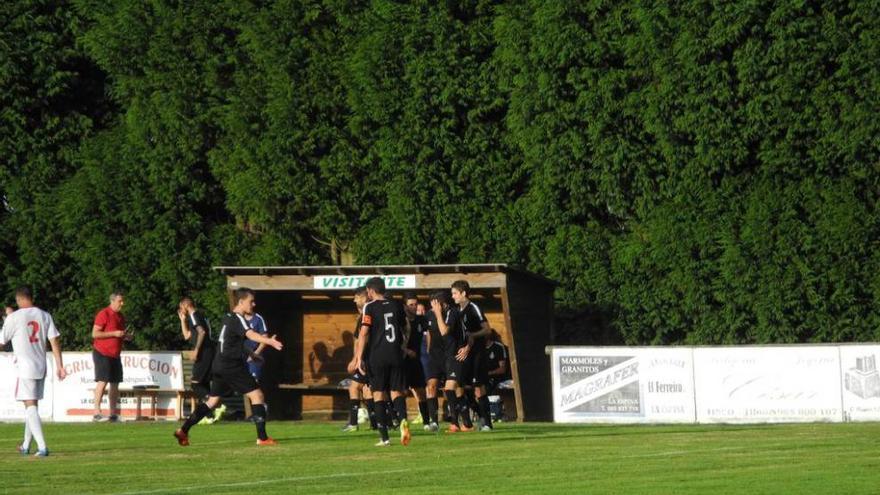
[694,346,843,423]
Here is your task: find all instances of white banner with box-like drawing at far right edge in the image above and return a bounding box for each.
[840,345,880,421]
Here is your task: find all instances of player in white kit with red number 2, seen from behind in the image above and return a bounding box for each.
[0,287,67,457]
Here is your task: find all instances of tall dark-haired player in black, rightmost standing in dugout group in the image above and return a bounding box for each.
[452,280,492,431]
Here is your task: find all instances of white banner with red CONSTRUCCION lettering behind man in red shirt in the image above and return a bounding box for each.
[54,351,183,421]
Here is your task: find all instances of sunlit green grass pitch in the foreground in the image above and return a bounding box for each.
[0,422,880,495]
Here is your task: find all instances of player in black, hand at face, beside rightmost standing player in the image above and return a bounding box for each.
[431,292,474,433]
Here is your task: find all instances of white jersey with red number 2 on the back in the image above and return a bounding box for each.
[0,306,59,380]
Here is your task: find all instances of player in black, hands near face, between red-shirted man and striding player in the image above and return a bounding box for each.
[177,297,215,401]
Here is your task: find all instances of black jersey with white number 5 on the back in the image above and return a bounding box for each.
[363,299,406,362]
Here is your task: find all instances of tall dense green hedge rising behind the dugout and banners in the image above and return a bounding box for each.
[0,0,880,347]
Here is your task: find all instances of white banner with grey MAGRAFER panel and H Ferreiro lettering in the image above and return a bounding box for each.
[551,347,695,423]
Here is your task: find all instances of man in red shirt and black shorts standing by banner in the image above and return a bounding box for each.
[92,291,131,422]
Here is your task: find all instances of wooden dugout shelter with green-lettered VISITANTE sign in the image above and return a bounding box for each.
[214,264,557,421]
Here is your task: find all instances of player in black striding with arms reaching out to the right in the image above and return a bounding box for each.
[174,287,283,446]
